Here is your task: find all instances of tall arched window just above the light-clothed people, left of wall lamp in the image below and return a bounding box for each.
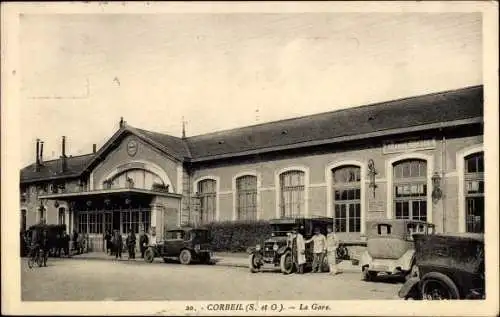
[332,165,361,232]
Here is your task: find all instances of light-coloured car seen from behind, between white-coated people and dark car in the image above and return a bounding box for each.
[359,219,434,281]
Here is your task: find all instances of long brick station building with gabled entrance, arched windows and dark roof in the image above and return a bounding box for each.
[21,86,484,248]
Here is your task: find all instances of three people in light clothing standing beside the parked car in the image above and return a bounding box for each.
[289,226,340,275]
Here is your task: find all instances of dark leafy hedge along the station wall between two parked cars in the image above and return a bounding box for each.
[204,220,272,252]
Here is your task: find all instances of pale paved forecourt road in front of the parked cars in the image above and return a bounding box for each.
[21,259,401,301]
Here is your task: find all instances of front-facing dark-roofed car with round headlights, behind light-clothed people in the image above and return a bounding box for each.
[248,217,333,274]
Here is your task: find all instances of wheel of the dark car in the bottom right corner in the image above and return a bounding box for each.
[421,272,460,300]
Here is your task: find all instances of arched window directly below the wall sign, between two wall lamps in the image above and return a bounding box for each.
[393,159,428,221]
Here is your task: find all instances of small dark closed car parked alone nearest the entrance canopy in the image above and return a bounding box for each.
[144,227,213,264]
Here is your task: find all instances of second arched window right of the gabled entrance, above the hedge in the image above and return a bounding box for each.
[236,175,257,220]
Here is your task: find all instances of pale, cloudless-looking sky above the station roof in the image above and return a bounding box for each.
[20,13,483,166]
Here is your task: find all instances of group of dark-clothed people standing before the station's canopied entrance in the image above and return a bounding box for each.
[104,230,149,259]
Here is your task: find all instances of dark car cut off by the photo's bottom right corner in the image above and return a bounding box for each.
[398,233,486,300]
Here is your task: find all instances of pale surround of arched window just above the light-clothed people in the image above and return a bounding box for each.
[325,160,367,234]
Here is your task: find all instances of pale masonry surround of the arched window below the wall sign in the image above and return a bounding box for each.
[385,152,434,223]
